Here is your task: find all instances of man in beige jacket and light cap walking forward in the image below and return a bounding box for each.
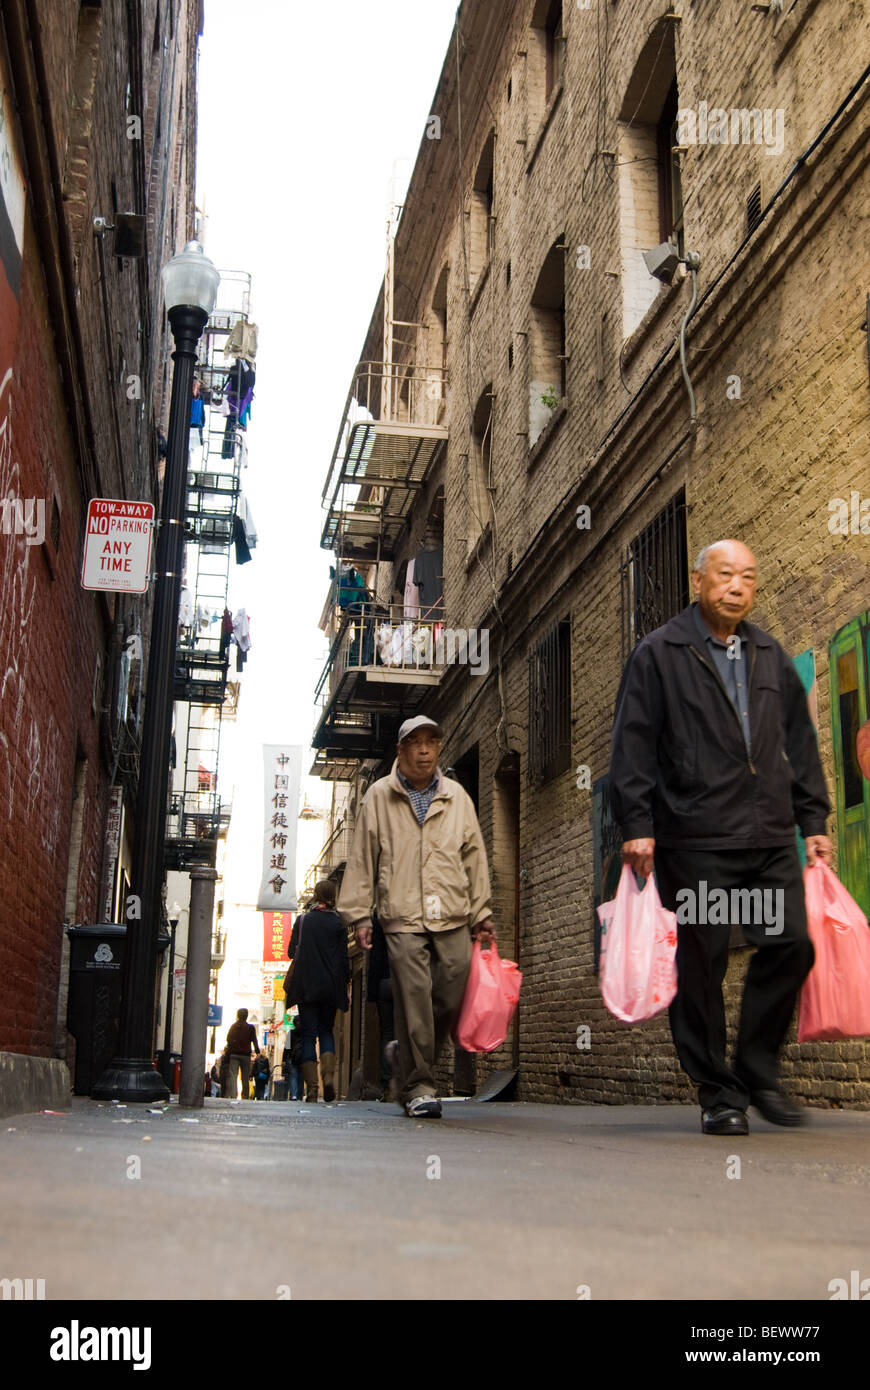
[338,714,495,1119]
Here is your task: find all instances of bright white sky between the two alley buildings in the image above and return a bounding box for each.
[197,0,457,949]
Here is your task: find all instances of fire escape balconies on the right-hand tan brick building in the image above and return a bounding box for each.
[311,198,449,781]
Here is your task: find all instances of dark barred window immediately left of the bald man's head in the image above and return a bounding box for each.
[620,488,691,662]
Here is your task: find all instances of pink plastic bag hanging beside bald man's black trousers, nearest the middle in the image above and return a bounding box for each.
[598,865,677,1023]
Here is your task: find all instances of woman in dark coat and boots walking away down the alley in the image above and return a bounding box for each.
[285,878,350,1101]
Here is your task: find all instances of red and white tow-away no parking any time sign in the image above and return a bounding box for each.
[82,498,154,594]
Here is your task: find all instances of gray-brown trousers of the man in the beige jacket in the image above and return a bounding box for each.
[385,927,471,1104]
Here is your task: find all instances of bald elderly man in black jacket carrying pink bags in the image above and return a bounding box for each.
[610,541,831,1136]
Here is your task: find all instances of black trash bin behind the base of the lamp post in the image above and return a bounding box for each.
[67,922,170,1095]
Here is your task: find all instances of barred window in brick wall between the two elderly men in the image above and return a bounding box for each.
[528,619,571,783]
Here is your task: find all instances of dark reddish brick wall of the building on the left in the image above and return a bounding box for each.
[0,0,197,1055]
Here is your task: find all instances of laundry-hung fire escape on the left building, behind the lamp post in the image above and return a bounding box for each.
[165,271,250,867]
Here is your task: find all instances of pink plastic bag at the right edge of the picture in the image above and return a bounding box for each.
[798,859,870,1043]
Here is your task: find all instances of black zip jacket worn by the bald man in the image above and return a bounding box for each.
[610,607,831,849]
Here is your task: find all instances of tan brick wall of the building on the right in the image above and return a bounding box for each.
[372,0,870,1105]
